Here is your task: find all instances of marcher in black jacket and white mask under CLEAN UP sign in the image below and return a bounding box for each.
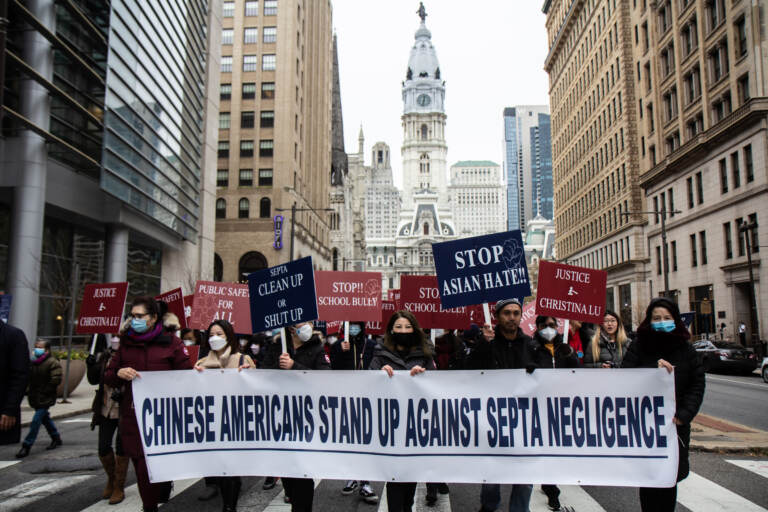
[278,322,331,512]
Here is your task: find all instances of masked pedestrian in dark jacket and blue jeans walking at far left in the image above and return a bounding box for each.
[16,340,62,459]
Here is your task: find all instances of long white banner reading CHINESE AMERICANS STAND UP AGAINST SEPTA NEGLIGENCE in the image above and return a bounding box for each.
[133,369,678,487]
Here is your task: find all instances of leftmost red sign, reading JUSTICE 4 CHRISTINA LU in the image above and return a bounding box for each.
[77,283,128,334]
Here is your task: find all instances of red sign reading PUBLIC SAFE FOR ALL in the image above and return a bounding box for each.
[189,281,253,334]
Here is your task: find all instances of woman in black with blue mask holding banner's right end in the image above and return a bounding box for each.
[621,297,704,512]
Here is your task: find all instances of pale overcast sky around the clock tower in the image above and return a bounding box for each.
[332,0,549,187]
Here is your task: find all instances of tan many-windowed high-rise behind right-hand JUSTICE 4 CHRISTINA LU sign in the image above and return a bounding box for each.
[543,0,649,325]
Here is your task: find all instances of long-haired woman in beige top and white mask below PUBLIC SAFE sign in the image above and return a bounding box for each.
[195,320,256,512]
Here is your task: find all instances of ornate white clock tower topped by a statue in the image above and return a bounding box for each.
[401,12,448,209]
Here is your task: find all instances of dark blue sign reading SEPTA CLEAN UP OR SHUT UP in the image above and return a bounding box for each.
[248,256,317,332]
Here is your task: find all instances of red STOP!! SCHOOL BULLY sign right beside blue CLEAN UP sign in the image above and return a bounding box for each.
[315,270,381,322]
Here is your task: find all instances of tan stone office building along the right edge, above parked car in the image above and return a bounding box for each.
[627,0,768,346]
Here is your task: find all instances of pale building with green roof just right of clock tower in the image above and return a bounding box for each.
[448,160,507,237]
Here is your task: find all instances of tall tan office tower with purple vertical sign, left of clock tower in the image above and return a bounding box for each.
[216,0,333,281]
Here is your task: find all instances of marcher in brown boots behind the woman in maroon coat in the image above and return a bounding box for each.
[85,336,130,505]
